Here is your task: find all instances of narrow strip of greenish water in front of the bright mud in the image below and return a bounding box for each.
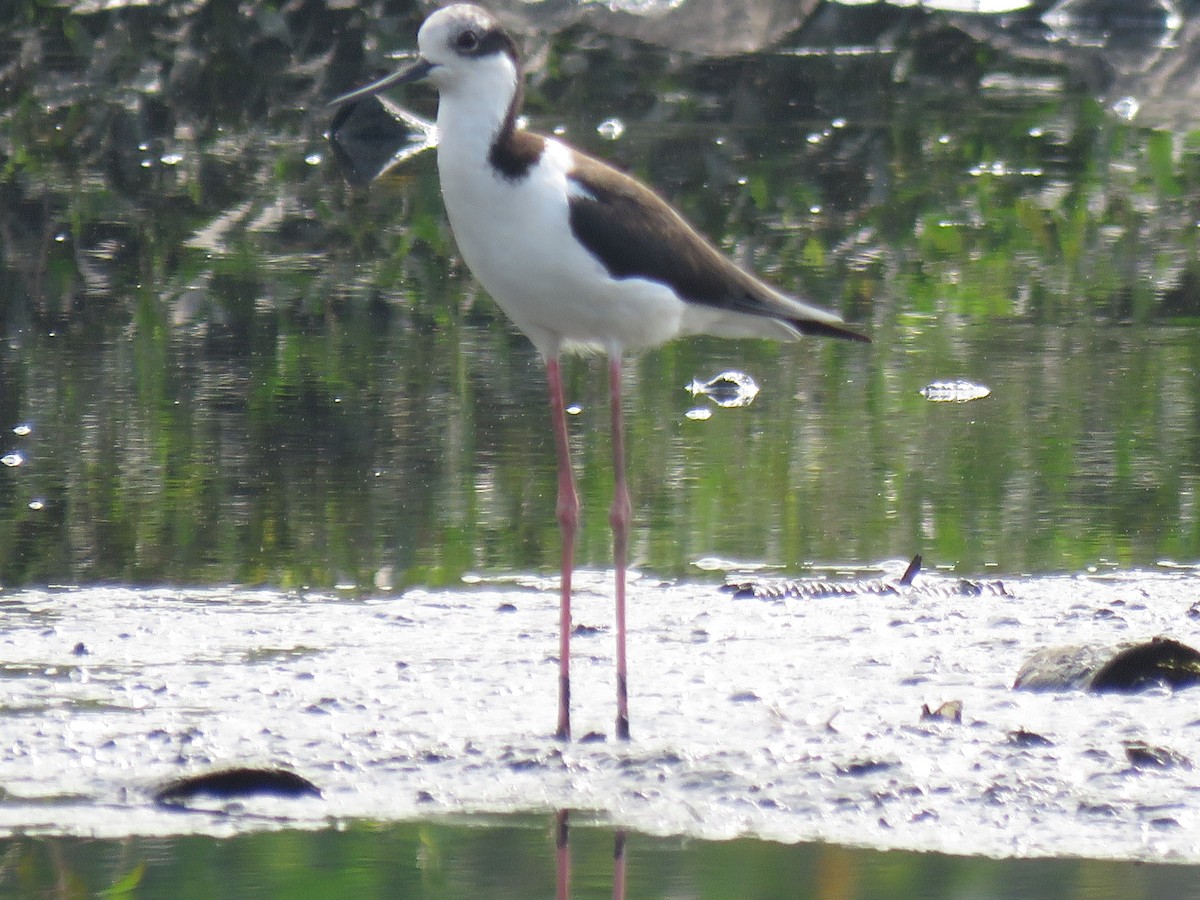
[0,818,1196,900]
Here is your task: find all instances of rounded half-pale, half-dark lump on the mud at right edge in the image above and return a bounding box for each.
[1013,637,1200,694]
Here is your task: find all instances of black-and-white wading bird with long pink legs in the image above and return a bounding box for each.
[330,4,870,740]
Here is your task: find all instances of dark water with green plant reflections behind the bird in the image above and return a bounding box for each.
[0,0,1200,592]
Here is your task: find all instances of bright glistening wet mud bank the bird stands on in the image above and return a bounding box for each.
[0,570,1200,863]
